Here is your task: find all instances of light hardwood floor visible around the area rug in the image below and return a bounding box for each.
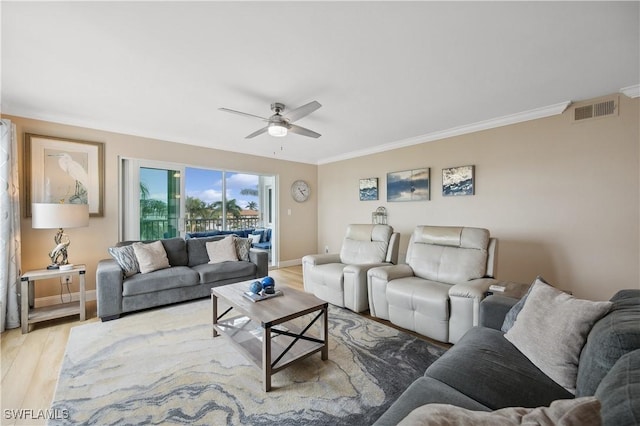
[0,266,448,426]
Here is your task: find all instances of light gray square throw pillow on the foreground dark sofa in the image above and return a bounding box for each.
[504,281,611,394]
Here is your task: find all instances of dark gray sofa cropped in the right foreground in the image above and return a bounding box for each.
[375,290,640,426]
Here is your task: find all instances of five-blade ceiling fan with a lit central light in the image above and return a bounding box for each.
[219,101,322,139]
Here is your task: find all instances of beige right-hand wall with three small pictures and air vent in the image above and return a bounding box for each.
[317,95,640,299]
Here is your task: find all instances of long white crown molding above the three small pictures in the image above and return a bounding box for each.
[318,101,571,165]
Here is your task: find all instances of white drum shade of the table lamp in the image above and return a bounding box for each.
[31,203,89,229]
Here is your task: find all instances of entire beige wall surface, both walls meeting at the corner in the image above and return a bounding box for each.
[7,96,640,299]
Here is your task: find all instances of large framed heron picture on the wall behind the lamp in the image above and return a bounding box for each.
[24,133,104,217]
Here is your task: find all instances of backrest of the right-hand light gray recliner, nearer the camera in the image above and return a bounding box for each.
[407,226,490,284]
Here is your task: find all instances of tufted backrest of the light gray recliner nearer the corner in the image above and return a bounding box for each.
[340,224,393,265]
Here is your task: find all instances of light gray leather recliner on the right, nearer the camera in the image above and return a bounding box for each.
[367,226,498,343]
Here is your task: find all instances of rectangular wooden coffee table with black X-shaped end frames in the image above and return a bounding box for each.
[211,280,329,392]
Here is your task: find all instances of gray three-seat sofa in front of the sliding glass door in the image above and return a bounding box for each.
[96,235,268,321]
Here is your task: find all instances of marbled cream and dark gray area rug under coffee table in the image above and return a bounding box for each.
[49,299,445,426]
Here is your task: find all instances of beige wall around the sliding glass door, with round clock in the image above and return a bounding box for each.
[4,116,317,298]
